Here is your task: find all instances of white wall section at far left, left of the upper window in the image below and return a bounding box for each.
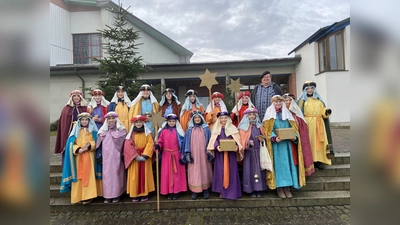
[50,3,73,66]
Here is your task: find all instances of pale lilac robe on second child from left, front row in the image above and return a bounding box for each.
[96,125,126,199]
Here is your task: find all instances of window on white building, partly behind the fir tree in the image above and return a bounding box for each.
[73,34,101,64]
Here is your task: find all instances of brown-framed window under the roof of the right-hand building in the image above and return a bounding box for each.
[318,30,344,72]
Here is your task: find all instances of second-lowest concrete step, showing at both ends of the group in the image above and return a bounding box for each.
[50,176,350,198]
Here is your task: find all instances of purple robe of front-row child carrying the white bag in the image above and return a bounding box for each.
[243,126,267,193]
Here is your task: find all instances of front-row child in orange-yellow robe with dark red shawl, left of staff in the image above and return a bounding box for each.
[124,115,155,202]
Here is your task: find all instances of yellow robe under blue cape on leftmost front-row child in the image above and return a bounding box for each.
[71,128,103,204]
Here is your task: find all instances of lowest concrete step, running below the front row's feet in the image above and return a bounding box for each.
[50,191,350,212]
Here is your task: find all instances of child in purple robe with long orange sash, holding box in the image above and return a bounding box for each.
[207,111,243,199]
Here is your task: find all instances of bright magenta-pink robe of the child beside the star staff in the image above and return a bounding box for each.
[158,127,187,195]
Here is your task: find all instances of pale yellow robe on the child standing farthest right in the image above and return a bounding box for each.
[304,98,332,165]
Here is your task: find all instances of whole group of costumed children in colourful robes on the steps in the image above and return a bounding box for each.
[55,82,332,204]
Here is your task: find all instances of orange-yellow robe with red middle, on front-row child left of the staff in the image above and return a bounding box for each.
[126,132,155,198]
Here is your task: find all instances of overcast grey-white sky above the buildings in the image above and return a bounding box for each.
[117,0,350,62]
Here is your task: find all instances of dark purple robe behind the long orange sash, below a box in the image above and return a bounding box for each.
[211,128,242,199]
